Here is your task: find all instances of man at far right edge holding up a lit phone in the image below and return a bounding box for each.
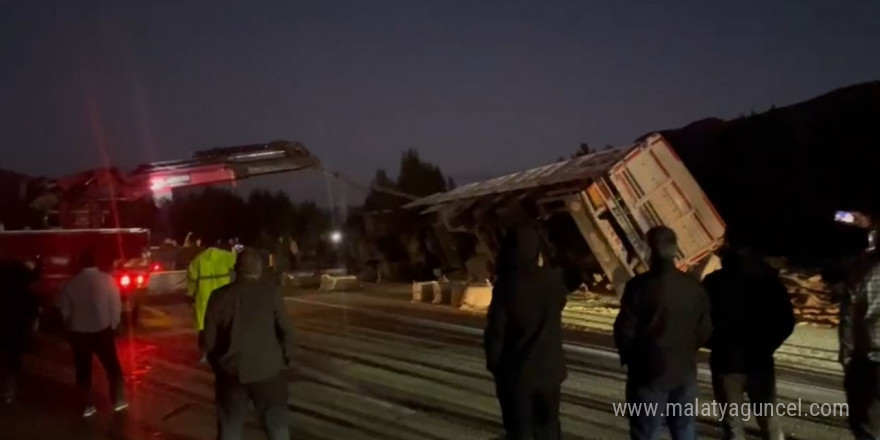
[838,212,880,440]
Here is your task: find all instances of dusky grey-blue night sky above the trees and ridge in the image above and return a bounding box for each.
[0,0,880,204]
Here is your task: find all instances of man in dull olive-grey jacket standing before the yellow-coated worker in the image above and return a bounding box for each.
[204,249,293,440]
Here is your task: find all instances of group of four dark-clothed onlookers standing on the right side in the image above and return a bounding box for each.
[484,217,880,440]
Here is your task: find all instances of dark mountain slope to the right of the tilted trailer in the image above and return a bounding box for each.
[661,81,880,262]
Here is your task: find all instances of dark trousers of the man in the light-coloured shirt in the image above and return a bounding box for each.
[70,328,124,405]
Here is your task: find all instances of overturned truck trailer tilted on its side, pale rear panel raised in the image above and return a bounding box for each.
[406,134,725,294]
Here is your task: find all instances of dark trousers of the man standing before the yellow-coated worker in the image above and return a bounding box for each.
[214,372,290,440]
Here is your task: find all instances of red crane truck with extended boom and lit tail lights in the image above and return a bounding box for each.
[0,141,320,328]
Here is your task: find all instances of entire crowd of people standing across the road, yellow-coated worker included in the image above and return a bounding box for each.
[0,217,880,440]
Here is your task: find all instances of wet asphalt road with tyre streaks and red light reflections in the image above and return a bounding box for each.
[0,293,848,440]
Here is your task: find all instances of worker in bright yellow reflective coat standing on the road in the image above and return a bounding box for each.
[186,245,235,362]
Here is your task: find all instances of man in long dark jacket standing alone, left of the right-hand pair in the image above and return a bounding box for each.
[484,226,568,440]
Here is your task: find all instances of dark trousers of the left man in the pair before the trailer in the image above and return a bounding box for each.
[626,378,698,440]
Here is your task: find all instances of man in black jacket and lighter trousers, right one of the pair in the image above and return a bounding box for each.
[703,239,794,440]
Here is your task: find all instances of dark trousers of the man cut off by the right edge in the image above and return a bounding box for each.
[843,356,880,440]
